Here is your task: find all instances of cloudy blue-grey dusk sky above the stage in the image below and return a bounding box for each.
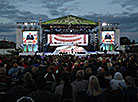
[0,0,138,41]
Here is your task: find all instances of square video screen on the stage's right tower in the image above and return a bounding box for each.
[102,31,115,44]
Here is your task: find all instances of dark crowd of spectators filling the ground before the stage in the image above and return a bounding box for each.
[0,54,138,102]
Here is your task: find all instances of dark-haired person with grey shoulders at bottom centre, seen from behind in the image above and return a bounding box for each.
[55,72,76,102]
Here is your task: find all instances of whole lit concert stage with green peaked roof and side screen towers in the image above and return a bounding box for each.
[16,15,120,55]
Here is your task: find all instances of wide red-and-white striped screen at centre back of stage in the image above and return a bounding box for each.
[47,34,88,46]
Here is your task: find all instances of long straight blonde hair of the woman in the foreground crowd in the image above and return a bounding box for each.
[87,75,102,96]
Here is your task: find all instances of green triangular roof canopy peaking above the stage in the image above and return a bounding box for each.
[42,15,98,25]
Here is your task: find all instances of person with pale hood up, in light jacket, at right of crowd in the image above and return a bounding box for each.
[110,72,126,90]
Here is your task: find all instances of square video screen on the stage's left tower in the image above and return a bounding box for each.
[23,31,38,44]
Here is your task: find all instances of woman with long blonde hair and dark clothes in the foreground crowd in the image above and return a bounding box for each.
[85,75,104,102]
